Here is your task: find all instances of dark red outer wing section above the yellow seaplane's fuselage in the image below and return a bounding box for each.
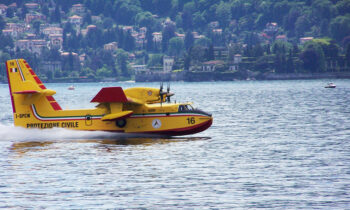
[91,87,128,103]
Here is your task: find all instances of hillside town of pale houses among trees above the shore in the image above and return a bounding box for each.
[0,1,350,81]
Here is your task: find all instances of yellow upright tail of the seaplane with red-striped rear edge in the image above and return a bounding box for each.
[6,59,62,125]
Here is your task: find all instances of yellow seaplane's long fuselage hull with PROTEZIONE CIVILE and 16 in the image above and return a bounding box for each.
[14,105,212,136]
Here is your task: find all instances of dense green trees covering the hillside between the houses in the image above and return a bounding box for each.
[0,0,350,81]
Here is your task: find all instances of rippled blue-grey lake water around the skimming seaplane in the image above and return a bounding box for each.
[0,80,350,209]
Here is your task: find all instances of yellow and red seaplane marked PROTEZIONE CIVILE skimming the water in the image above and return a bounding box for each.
[6,59,213,136]
